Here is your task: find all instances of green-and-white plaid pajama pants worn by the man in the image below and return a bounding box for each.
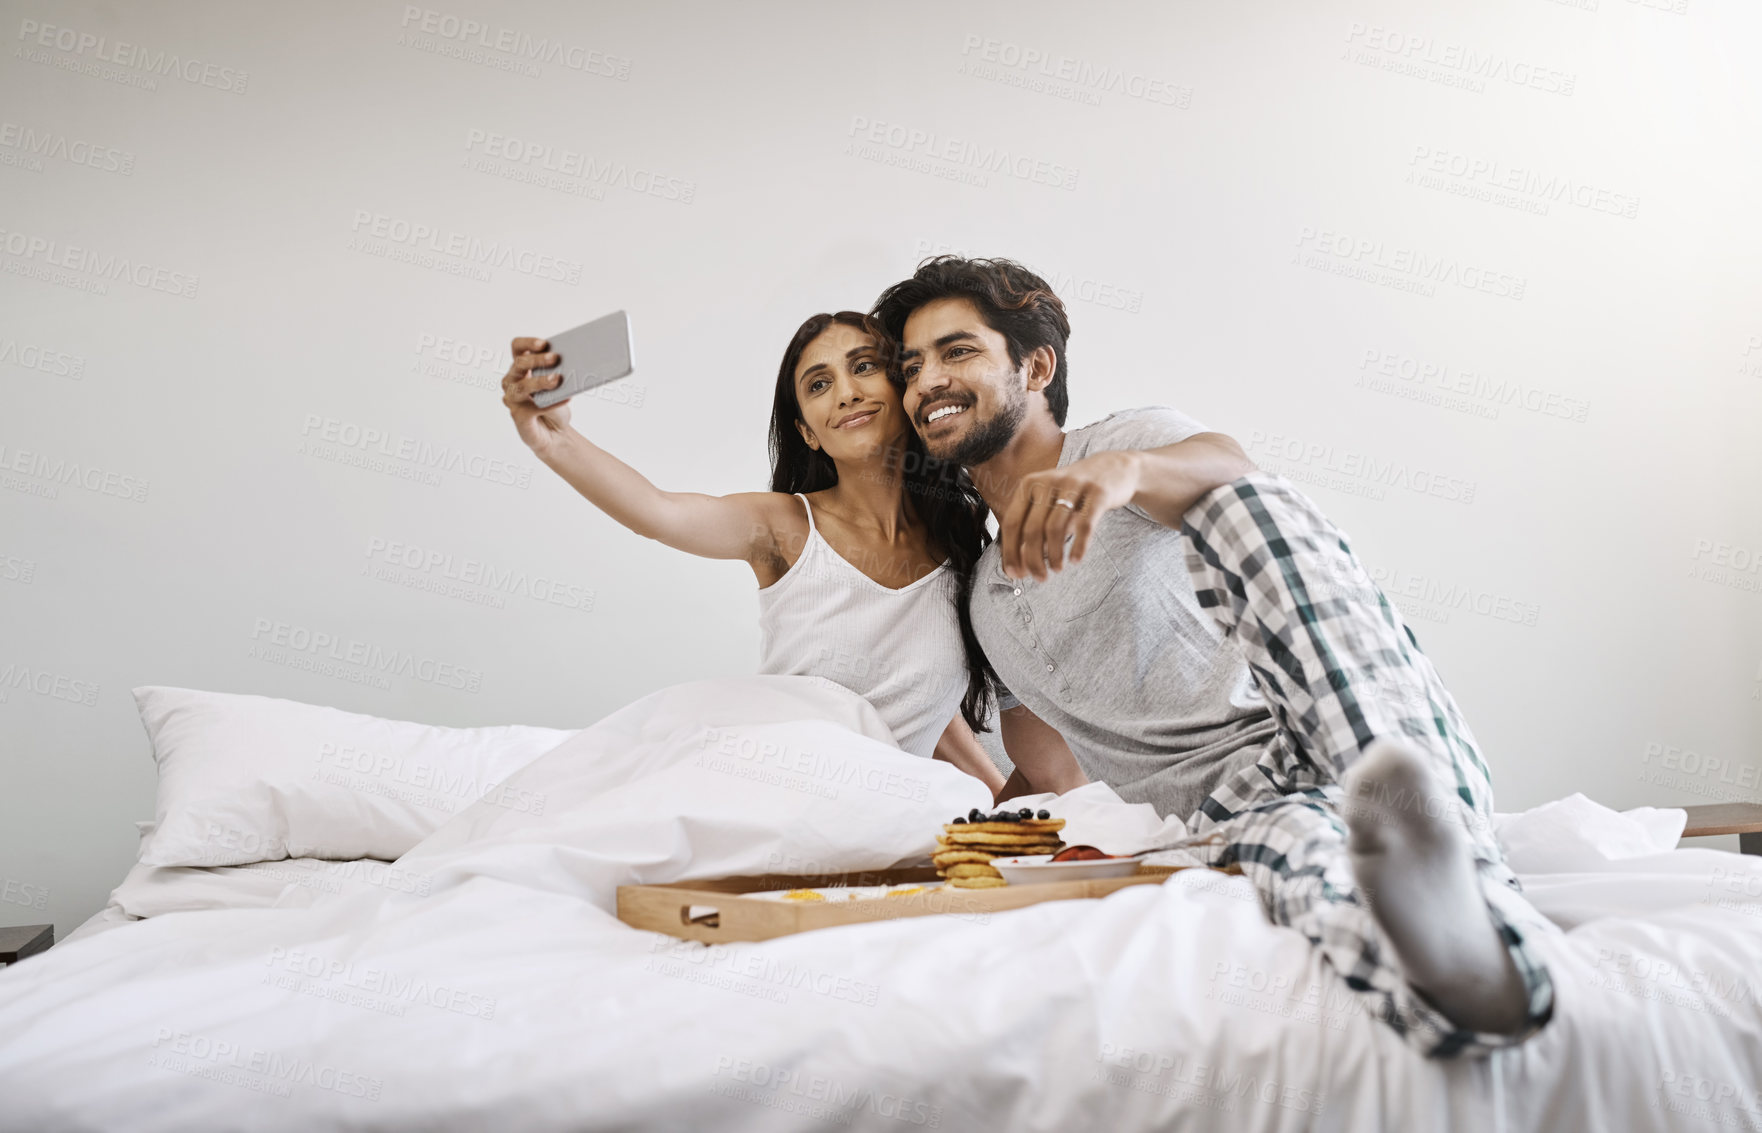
[1181,472,1558,1057]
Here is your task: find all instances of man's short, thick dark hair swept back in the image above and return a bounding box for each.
[869,255,1071,428]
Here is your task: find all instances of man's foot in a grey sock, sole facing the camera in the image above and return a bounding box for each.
[1341,738,1529,1034]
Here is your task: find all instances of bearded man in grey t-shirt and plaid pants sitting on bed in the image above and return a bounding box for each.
[872,255,1554,1057]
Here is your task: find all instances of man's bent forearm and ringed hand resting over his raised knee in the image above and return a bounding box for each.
[997,433,1258,581]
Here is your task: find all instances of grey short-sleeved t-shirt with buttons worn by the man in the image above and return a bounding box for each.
[971,405,1276,818]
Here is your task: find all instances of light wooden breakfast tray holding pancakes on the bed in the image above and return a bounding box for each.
[618,865,1240,944]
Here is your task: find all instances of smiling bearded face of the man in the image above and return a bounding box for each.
[900,298,1027,467]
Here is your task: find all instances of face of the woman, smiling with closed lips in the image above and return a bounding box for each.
[795,322,911,460]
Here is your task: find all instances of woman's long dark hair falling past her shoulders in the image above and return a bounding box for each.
[770,310,997,731]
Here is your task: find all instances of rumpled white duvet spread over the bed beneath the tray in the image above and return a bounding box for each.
[0,677,1762,1133]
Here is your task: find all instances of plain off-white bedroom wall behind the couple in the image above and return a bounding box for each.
[0,0,1762,934]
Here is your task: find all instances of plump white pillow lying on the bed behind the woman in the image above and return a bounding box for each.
[134,685,576,865]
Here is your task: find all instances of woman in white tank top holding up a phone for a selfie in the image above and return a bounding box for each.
[502,310,1071,796]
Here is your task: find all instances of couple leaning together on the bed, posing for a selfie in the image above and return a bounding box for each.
[502,255,1554,1057]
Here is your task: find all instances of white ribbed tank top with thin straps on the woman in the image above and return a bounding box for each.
[759,492,967,758]
